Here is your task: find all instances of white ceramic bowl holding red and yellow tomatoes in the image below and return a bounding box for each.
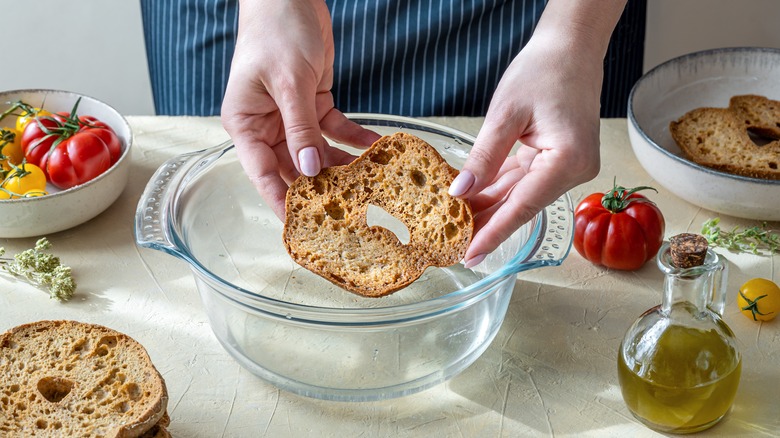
[0,90,132,238]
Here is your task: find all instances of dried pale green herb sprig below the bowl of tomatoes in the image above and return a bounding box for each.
[0,237,76,301]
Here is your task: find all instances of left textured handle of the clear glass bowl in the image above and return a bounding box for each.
[135,141,233,257]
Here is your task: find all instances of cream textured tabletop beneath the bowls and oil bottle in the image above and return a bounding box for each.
[0,117,780,438]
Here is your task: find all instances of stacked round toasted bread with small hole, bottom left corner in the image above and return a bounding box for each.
[0,321,168,438]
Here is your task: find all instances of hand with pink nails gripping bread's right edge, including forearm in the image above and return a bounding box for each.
[450,2,620,267]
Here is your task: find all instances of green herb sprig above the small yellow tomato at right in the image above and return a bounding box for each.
[701,218,780,255]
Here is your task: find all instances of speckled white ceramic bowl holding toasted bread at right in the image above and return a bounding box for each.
[628,47,780,221]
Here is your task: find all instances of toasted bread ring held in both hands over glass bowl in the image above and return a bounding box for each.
[284,133,473,297]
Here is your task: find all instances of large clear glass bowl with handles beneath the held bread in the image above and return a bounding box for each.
[135,114,573,401]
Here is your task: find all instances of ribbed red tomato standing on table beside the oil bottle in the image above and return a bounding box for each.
[573,181,666,271]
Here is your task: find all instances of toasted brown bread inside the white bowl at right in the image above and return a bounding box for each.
[669,95,780,179]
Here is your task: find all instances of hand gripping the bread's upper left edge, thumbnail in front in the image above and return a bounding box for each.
[222,0,379,219]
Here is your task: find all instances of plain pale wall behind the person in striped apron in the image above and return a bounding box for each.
[0,0,780,115]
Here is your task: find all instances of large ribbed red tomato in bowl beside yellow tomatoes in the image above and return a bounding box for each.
[21,102,122,189]
